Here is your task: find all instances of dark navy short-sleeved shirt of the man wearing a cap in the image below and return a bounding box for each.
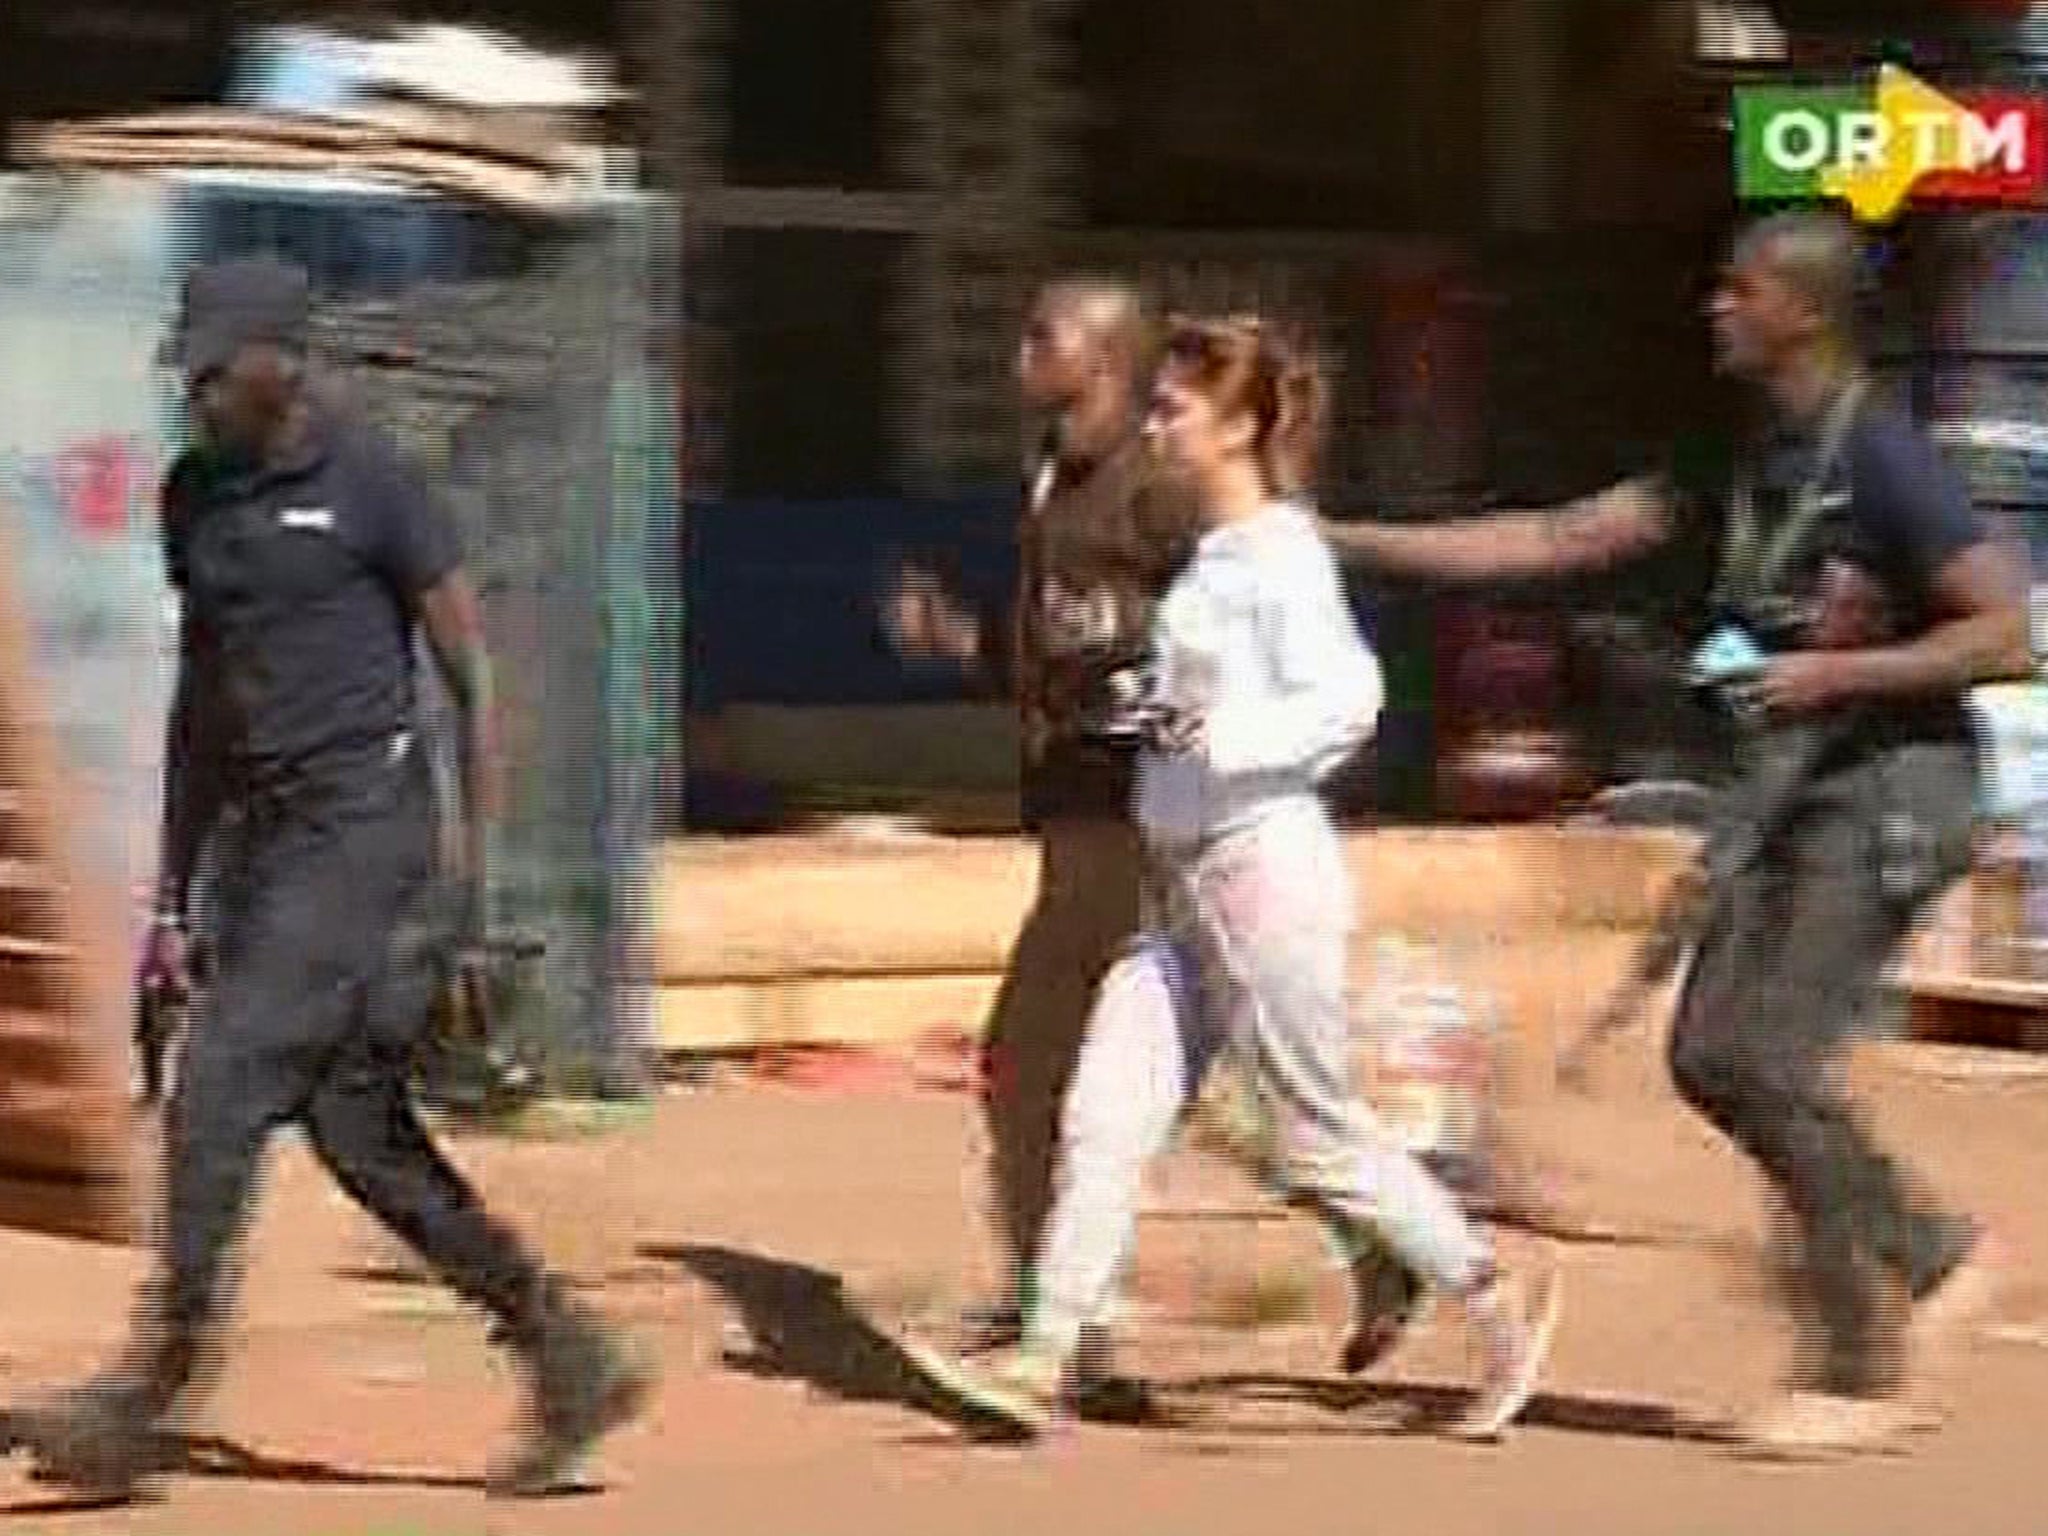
[162,418,461,784]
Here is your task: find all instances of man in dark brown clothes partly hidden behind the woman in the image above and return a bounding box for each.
[891,276,1413,1415]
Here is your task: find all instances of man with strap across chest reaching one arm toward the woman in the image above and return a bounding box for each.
[1329,213,2032,1456]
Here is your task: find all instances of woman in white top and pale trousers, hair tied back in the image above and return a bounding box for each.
[920,319,1556,1440]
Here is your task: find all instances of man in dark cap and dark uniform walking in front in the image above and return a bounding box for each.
[12,260,651,1497]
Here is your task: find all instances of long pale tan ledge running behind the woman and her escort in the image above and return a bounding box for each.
[657,827,1692,1051]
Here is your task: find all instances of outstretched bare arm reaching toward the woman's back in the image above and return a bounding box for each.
[1323,479,1671,584]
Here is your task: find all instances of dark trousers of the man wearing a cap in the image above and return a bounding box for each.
[152,750,539,1386]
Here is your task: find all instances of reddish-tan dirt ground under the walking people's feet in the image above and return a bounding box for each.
[0,1040,2048,1536]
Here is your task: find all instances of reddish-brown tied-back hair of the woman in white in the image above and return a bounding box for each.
[1161,315,1329,496]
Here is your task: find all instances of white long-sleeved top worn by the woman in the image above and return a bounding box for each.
[1135,502,1384,850]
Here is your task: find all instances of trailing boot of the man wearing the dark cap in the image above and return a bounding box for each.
[487,1282,655,1499]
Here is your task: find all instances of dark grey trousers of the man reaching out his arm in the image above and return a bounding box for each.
[1671,743,1976,1395]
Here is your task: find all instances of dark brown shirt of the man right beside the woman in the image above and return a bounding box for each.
[1004,432,1196,825]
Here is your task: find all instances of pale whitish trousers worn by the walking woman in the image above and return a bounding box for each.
[1028,811,1491,1356]
